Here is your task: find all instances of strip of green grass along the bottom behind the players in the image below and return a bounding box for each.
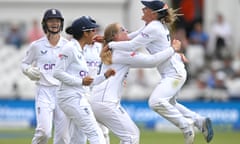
[0,129,240,144]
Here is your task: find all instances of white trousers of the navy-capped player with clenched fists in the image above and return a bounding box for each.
[58,94,106,144]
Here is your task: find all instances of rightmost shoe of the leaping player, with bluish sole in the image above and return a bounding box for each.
[202,118,214,143]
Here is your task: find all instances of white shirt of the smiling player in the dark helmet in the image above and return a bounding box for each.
[21,37,68,86]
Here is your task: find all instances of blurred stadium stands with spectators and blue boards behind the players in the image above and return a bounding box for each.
[0,0,240,144]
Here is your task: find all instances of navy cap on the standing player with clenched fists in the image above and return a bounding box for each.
[66,16,98,35]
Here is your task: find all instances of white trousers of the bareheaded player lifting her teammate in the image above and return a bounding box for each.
[90,101,140,144]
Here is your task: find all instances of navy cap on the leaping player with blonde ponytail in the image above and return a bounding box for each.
[141,0,168,11]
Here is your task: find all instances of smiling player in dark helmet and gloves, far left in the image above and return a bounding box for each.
[22,9,69,144]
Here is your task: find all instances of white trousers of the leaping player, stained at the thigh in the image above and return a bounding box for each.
[148,73,202,133]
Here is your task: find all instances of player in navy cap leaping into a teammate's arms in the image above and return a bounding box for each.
[105,0,213,144]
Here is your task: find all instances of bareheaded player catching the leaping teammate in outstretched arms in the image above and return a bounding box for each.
[89,23,181,144]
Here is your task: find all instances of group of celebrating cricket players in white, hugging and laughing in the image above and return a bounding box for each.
[22,0,214,144]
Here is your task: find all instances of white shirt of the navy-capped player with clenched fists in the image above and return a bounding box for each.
[54,39,105,97]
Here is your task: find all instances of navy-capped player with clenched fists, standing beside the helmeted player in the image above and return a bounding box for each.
[53,16,115,144]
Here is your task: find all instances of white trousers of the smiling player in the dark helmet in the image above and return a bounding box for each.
[32,86,69,144]
